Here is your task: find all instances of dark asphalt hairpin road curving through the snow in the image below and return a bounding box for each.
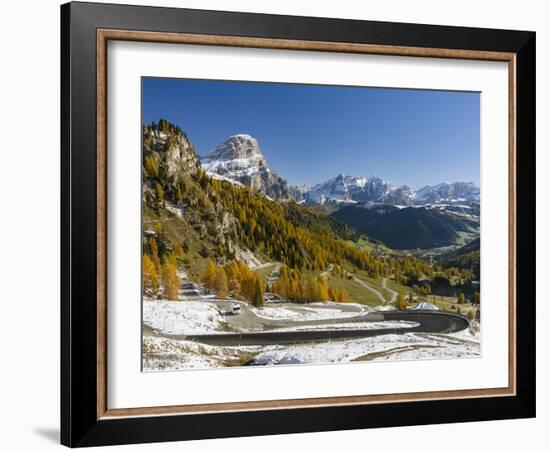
[184,311,470,346]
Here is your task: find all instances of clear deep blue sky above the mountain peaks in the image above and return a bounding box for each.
[143,78,480,188]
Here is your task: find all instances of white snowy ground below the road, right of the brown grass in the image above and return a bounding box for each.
[252,330,481,365]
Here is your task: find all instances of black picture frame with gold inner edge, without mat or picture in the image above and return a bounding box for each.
[61,3,536,446]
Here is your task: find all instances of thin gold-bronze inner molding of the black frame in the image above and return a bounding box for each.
[97,29,516,420]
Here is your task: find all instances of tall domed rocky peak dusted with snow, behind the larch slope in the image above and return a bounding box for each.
[201,134,292,199]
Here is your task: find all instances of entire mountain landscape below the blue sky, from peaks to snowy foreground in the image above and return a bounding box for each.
[142,119,480,370]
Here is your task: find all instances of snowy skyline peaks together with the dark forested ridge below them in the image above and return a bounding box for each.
[200,134,480,249]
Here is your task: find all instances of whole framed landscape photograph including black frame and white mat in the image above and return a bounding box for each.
[61,3,536,447]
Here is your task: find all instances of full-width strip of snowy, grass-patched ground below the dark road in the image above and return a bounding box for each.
[143,330,481,371]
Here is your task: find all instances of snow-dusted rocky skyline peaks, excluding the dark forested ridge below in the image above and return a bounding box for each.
[201,134,480,210]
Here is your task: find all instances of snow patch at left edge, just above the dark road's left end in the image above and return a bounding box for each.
[143,300,229,334]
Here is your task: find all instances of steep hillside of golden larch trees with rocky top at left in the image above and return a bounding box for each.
[143,120,392,272]
